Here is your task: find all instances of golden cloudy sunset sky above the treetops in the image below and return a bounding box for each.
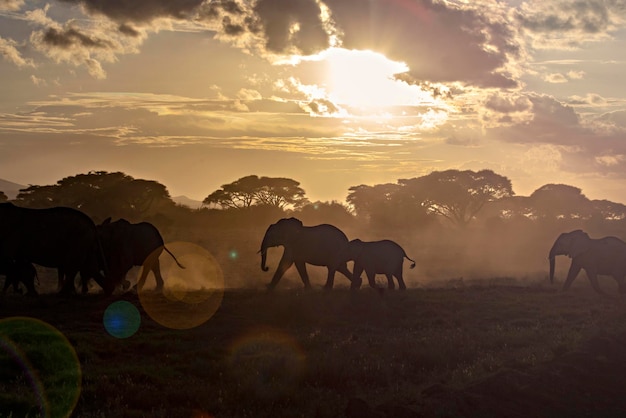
[0,0,626,203]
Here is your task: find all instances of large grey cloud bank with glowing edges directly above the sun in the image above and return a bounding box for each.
[205,0,522,88]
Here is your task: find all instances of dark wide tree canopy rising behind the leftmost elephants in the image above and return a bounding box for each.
[15,171,174,221]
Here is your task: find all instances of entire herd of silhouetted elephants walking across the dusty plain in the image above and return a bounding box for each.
[0,203,626,295]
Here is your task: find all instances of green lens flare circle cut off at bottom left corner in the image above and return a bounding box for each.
[0,317,82,417]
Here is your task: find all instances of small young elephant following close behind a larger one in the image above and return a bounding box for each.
[348,239,415,290]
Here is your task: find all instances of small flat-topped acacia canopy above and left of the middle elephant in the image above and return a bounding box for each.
[202,175,308,209]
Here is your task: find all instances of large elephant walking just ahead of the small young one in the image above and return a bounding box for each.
[259,218,352,290]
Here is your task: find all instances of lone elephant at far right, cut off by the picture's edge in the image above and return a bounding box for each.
[548,229,626,295]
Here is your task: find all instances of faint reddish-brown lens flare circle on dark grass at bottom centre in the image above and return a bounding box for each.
[229,328,306,399]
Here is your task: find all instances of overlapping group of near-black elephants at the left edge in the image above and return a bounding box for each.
[0,203,182,295]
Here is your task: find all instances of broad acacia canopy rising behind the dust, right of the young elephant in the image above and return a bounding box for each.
[398,170,514,226]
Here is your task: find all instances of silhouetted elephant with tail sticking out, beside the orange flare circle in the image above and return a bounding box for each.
[98,218,185,291]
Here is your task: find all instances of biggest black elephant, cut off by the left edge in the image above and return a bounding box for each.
[0,202,113,295]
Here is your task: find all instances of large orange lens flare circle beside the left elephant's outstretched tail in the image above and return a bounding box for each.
[138,242,224,329]
